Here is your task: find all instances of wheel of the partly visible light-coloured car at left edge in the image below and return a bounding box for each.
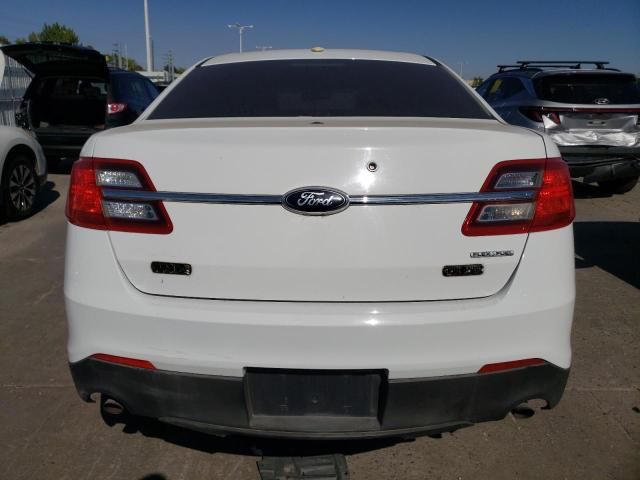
[2,155,38,220]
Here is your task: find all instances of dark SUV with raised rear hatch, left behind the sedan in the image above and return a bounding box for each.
[0,43,158,166]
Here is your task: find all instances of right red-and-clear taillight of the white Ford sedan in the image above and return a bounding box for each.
[462,158,575,236]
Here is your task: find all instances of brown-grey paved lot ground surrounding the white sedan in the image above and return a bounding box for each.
[0,166,640,480]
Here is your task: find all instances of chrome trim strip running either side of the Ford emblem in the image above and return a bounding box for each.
[102,188,536,205]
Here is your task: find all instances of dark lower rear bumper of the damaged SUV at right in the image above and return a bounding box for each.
[558,146,640,182]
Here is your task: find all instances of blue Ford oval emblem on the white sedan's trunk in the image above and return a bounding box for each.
[282,187,349,215]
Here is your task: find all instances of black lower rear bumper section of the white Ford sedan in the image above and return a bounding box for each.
[70,358,569,439]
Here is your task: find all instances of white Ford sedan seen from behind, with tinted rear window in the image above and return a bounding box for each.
[65,49,574,438]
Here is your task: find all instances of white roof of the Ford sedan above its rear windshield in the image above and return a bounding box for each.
[200,47,436,67]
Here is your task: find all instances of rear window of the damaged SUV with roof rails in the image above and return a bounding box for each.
[535,73,640,105]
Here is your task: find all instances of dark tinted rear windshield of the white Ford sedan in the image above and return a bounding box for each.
[149,60,492,119]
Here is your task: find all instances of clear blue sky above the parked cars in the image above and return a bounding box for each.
[0,0,640,78]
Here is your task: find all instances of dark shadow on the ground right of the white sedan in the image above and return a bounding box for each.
[573,222,640,288]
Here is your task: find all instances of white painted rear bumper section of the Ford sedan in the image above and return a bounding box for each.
[65,225,575,380]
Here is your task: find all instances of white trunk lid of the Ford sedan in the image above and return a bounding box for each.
[94,118,545,301]
